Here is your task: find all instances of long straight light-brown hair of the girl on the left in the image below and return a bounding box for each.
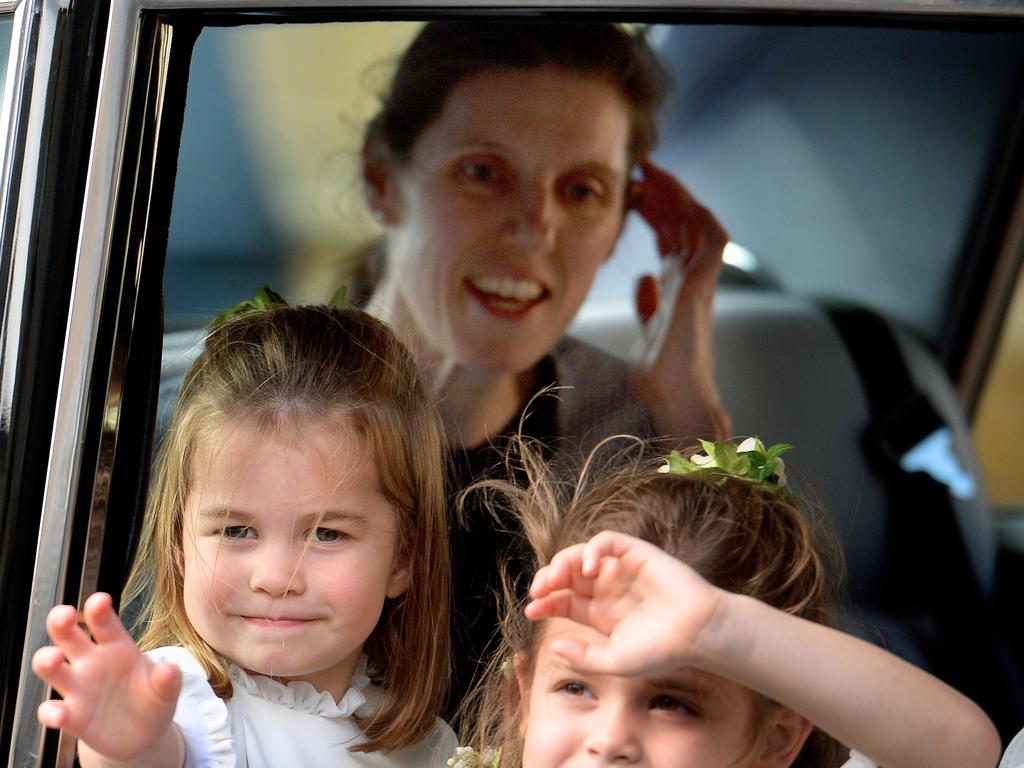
[123,306,450,752]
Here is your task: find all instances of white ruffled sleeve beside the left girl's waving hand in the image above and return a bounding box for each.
[145,646,237,768]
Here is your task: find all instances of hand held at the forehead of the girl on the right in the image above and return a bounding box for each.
[526,531,723,675]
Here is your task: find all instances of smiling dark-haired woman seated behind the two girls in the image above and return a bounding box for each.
[364,20,729,700]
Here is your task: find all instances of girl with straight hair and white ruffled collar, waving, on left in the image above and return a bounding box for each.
[33,303,454,768]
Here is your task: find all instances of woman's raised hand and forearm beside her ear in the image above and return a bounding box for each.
[631,162,730,438]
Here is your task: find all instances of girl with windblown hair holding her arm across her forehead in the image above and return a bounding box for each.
[462,441,999,768]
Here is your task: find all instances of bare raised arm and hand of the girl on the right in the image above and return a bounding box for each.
[526,531,999,768]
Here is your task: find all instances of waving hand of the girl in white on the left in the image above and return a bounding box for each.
[32,593,181,761]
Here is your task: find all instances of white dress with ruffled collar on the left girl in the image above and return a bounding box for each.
[146,646,457,768]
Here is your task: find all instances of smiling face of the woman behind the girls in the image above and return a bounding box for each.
[372,68,630,373]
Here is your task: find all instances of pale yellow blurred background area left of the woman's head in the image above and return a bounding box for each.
[222,22,422,301]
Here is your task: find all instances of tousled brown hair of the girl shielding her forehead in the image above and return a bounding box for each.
[461,438,841,767]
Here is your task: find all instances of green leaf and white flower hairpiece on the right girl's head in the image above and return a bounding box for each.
[657,437,793,490]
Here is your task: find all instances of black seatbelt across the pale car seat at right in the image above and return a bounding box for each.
[826,306,1024,739]
